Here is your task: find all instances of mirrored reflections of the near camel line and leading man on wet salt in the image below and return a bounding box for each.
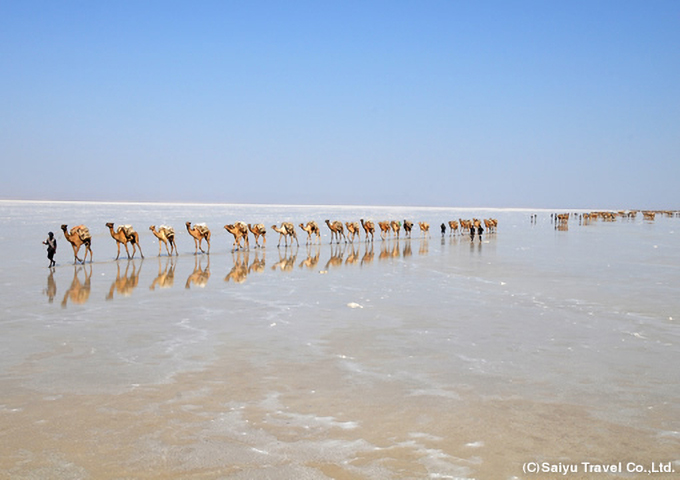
[43,236,489,307]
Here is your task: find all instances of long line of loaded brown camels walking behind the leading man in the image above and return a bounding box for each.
[54,218,498,264]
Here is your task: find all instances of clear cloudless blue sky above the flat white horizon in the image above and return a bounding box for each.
[0,0,680,209]
